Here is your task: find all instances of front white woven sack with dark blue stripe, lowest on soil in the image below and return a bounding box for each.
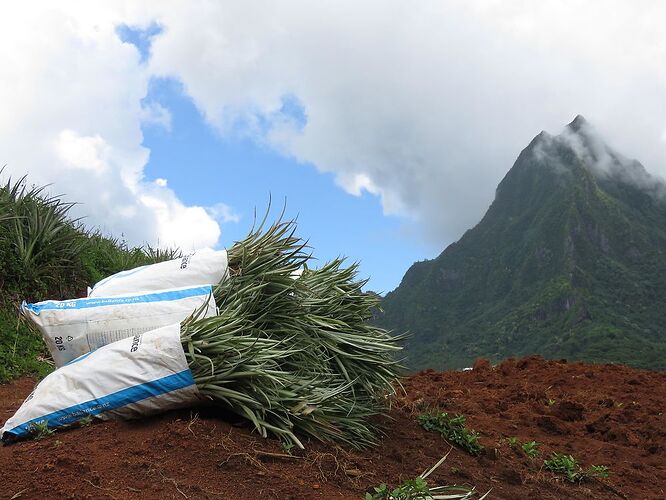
[0,324,199,442]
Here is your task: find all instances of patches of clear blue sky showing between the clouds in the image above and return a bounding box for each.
[128,26,430,293]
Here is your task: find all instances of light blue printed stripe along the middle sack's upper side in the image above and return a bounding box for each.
[21,285,213,314]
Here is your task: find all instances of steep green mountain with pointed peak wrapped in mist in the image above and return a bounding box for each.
[379,116,666,369]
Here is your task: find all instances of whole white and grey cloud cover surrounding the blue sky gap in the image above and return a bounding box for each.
[0,0,666,248]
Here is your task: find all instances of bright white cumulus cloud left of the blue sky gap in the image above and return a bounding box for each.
[0,1,220,249]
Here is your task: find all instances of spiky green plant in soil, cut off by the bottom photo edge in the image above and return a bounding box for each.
[365,452,490,500]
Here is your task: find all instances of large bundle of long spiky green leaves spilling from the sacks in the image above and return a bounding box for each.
[181,215,403,448]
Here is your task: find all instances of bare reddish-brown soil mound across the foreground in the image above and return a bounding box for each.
[0,357,666,499]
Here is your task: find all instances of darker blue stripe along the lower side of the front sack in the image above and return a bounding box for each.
[2,370,194,441]
